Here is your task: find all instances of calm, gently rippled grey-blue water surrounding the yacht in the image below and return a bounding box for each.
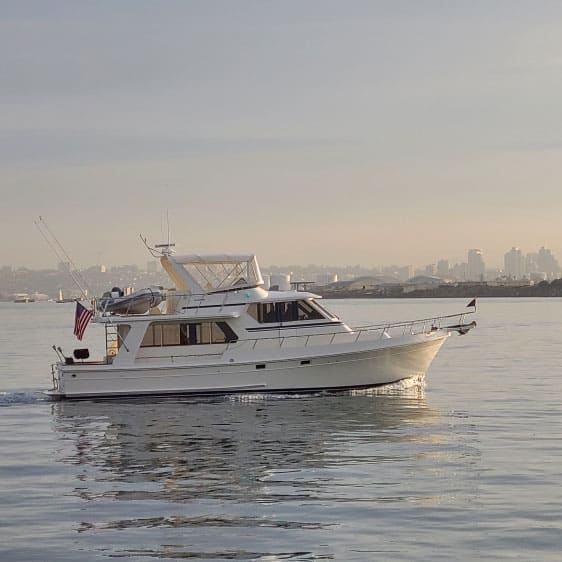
[0,299,562,562]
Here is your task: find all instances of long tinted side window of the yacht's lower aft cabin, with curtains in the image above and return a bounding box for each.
[141,322,238,347]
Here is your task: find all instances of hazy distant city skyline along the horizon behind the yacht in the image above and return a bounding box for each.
[0,242,562,300]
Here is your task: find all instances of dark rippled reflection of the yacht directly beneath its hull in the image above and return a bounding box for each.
[54,389,437,494]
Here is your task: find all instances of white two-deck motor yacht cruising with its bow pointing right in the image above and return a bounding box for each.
[47,244,476,399]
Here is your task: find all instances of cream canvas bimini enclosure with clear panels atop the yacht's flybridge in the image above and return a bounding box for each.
[160,254,263,294]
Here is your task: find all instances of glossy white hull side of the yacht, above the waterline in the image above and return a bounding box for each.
[49,330,449,398]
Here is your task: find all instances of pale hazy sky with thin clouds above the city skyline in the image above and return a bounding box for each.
[0,0,562,268]
